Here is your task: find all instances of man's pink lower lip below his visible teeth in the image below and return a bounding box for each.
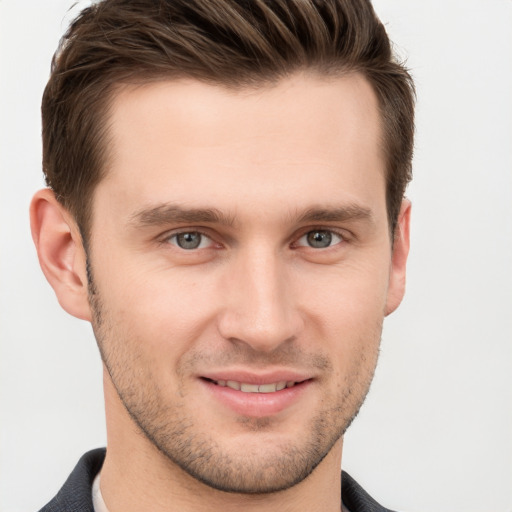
[201,379,311,418]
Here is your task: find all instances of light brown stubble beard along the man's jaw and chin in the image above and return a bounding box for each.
[88,265,381,495]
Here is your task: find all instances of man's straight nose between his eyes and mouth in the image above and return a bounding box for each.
[219,248,303,352]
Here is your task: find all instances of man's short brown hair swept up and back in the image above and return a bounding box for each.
[42,0,414,241]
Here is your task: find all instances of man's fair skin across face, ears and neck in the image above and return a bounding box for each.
[31,74,410,512]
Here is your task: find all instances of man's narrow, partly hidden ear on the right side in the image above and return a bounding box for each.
[385,199,411,316]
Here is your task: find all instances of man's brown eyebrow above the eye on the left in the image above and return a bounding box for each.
[130,204,234,227]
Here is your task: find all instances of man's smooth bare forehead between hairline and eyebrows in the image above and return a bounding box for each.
[97,74,385,228]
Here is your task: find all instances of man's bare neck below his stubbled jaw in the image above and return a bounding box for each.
[101,370,342,512]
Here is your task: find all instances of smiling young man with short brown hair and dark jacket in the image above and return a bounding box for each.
[31,0,413,512]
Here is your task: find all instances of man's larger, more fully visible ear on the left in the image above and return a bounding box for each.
[30,189,91,321]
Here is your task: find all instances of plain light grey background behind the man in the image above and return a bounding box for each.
[0,0,512,512]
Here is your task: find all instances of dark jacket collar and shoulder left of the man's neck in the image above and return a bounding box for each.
[39,448,106,512]
